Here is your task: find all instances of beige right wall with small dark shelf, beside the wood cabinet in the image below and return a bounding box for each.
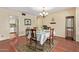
[38,8,75,37]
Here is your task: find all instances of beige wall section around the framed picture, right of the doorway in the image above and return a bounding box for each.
[19,14,36,36]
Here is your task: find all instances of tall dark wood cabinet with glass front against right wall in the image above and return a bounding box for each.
[65,16,74,40]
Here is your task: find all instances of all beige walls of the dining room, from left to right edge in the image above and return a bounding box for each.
[0,8,76,40]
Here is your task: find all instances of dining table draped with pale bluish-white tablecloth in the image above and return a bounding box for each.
[28,30,55,45]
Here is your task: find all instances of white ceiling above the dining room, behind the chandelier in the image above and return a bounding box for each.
[7,7,70,16]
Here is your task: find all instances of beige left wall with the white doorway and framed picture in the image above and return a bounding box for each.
[0,8,36,40]
